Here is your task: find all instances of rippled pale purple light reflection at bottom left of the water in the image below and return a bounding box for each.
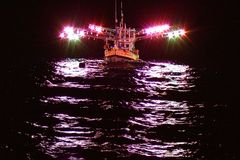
[36,114,101,158]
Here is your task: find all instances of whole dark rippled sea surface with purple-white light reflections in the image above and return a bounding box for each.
[0,58,239,160]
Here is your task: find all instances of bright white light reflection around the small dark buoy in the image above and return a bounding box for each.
[43,59,104,89]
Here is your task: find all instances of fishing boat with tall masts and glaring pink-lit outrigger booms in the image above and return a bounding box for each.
[59,0,186,62]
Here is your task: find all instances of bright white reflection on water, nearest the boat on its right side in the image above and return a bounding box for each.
[135,62,196,96]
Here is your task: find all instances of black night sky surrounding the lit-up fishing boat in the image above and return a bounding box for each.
[2,0,240,69]
